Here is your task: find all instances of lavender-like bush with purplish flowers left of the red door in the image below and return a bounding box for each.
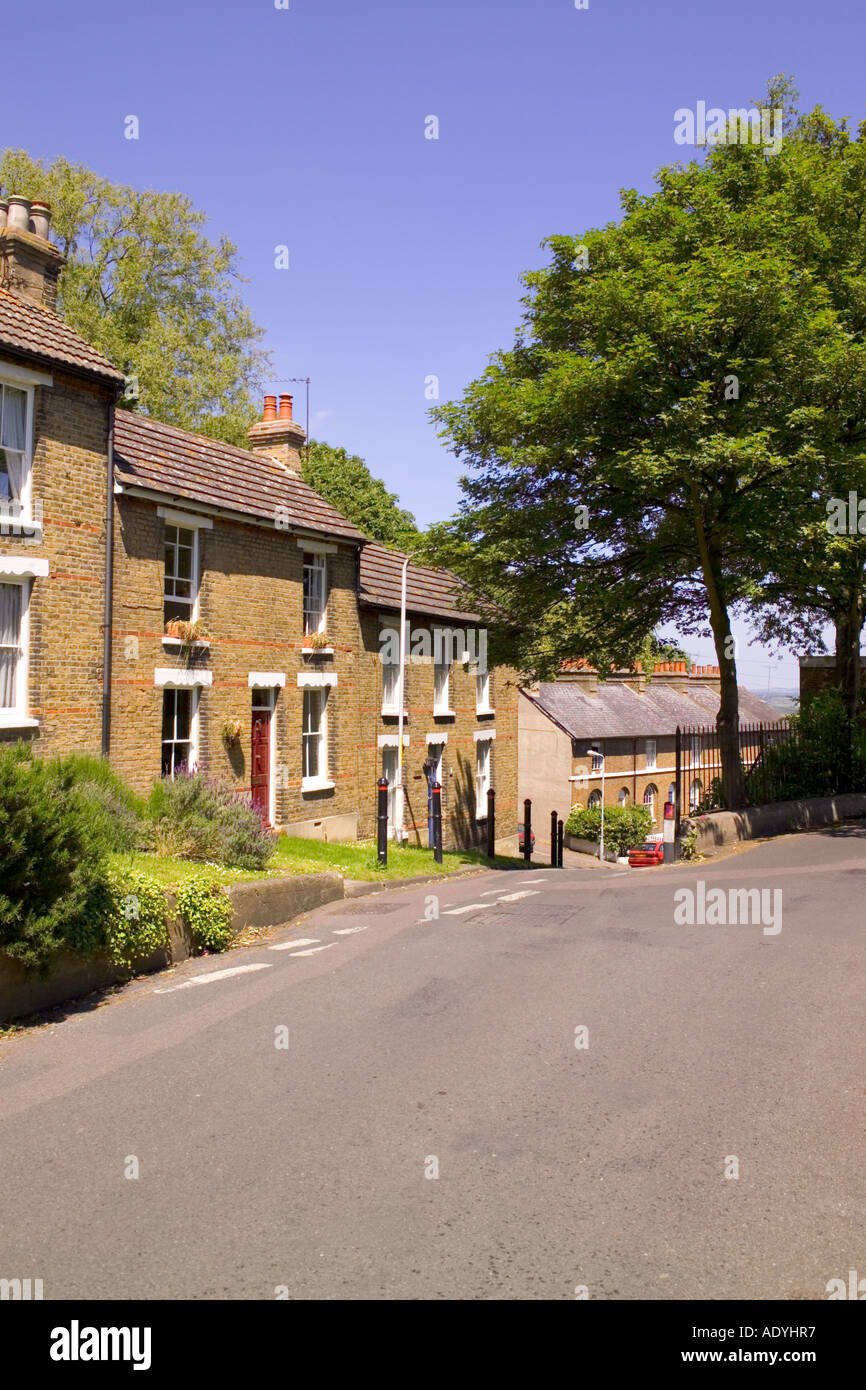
[147,773,277,869]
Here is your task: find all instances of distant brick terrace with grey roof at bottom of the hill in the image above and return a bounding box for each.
[518,660,778,841]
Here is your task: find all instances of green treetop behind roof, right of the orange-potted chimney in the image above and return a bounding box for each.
[302,439,418,550]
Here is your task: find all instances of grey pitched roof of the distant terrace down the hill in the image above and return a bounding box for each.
[523,680,780,738]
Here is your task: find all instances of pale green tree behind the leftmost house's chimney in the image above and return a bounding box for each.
[0,149,268,446]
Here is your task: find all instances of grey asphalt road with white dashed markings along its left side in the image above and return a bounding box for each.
[0,827,866,1300]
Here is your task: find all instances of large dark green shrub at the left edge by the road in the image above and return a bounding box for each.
[0,744,103,972]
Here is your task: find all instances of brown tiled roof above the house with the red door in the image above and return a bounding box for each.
[114,410,364,542]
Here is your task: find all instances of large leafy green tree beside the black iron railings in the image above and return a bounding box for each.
[428,79,866,808]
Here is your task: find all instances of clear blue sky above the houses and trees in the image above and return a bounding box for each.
[0,0,866,689]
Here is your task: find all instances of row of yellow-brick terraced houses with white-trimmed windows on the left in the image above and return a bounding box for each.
[0,199,517,845]
